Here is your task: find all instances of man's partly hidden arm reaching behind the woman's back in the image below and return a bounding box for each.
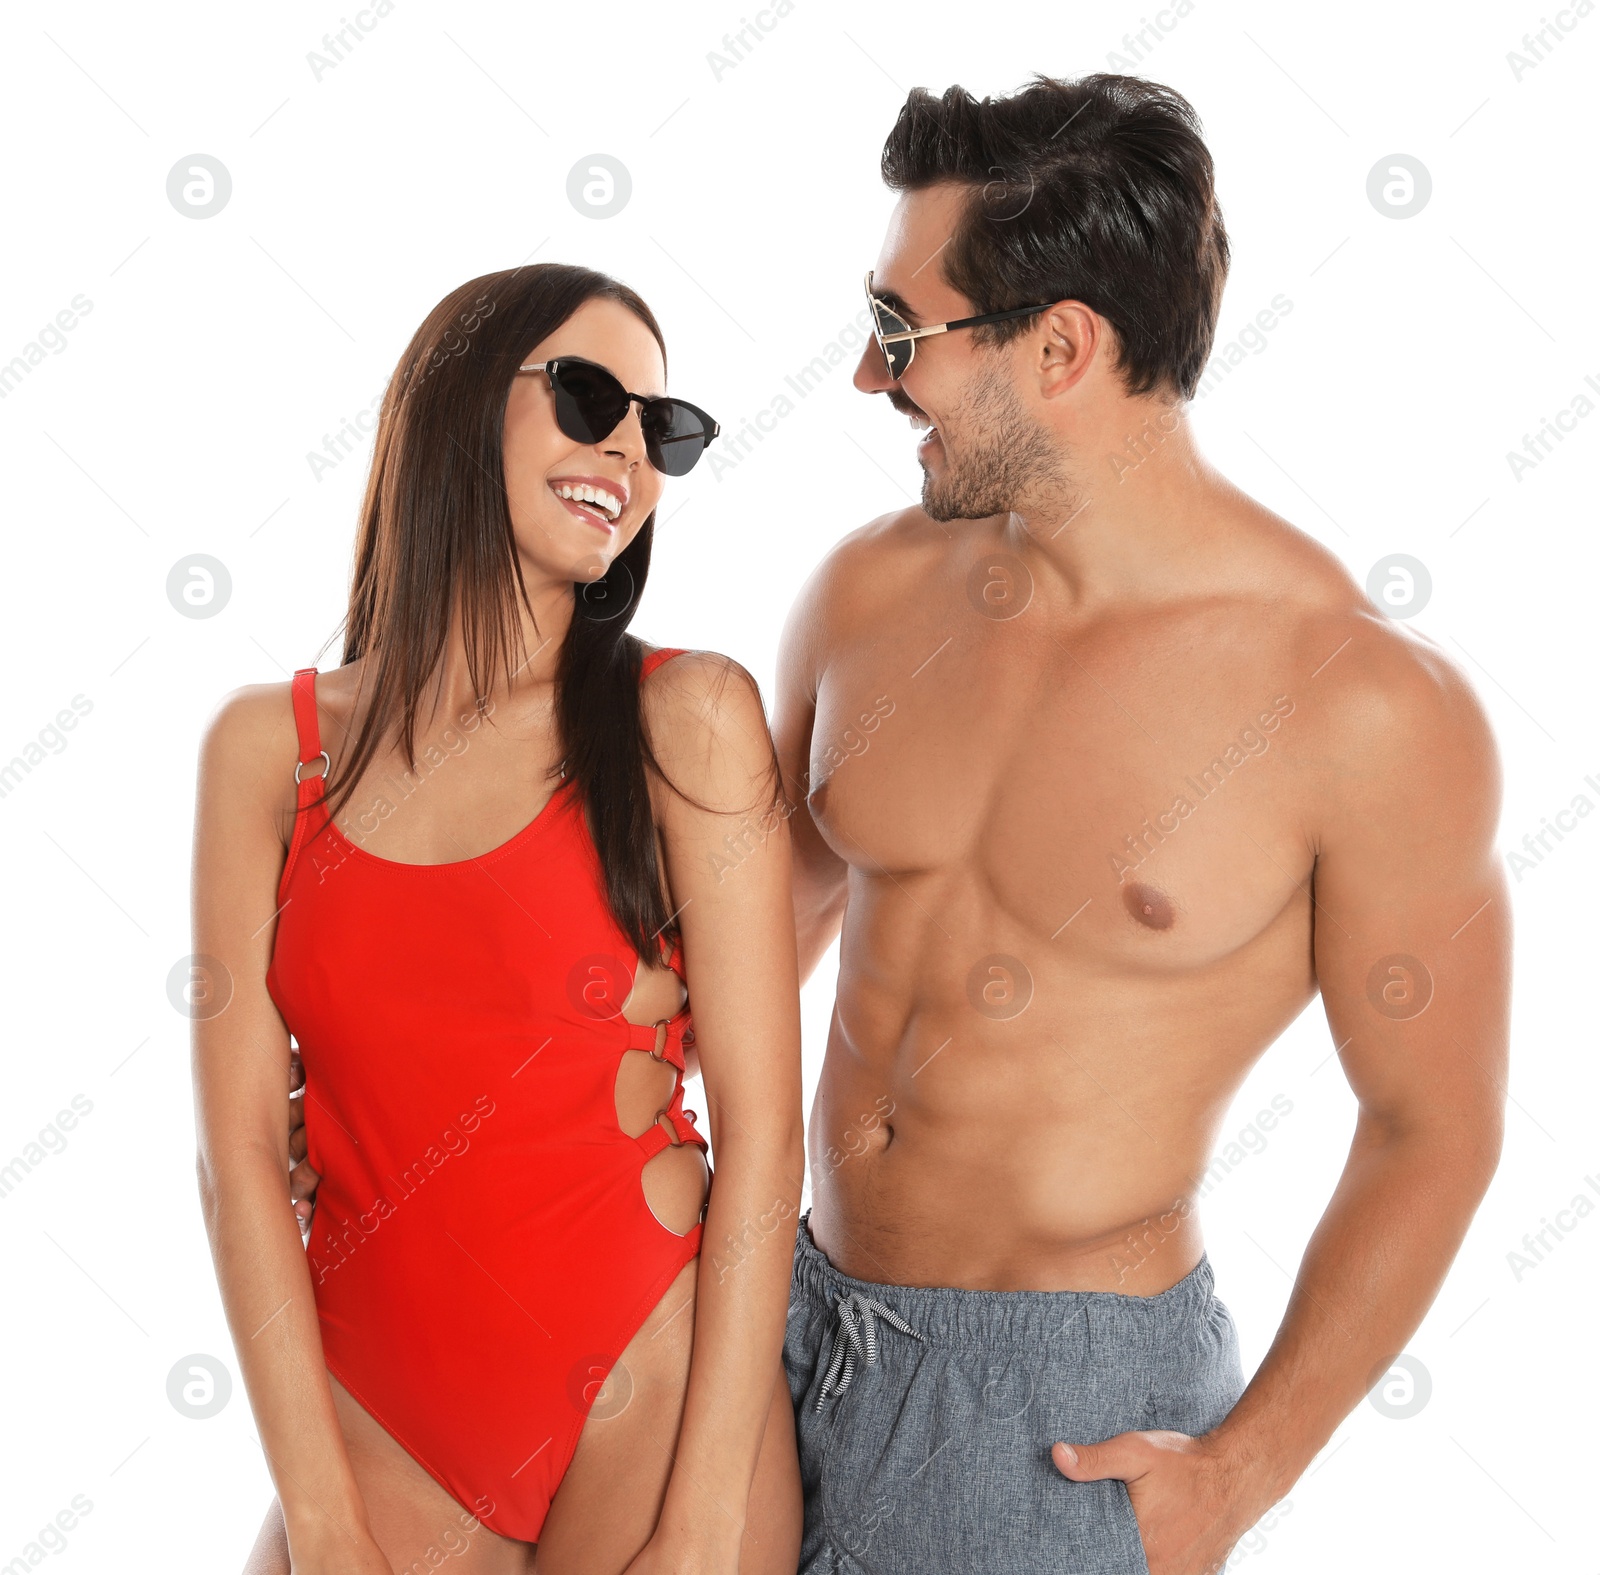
[773,538,853,984]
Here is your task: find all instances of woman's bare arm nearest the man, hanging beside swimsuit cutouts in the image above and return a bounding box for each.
[645,651,805,1572]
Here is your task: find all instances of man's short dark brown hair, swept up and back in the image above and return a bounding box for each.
[883,72,1227,399]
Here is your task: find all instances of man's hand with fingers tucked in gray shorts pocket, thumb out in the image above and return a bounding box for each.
[1050,1431,1258,1575]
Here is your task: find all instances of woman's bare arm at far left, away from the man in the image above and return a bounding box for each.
[194,685,390,1575]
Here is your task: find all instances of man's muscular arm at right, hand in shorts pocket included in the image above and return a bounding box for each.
[1056,631,1510,1575]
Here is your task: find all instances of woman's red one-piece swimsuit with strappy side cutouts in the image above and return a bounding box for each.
[267,650,707,1543]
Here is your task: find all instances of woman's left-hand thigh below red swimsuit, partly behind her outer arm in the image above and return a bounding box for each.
[245,1373,533,1575]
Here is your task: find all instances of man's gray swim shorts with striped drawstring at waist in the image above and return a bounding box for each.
[784,1210,1245,1575]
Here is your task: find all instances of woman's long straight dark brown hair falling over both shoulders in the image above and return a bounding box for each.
[315,263,716,960]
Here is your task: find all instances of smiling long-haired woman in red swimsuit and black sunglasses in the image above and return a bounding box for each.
[194,264,803,1575]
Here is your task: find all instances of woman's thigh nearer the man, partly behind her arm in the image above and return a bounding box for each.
[536,1260,800,1575]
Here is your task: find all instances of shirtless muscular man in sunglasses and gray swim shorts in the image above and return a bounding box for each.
[776,75,1509,1575]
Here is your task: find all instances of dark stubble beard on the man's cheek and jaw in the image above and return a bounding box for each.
[922,356,1077,523]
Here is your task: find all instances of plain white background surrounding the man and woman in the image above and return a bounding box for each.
[0,0,1600,1575]
